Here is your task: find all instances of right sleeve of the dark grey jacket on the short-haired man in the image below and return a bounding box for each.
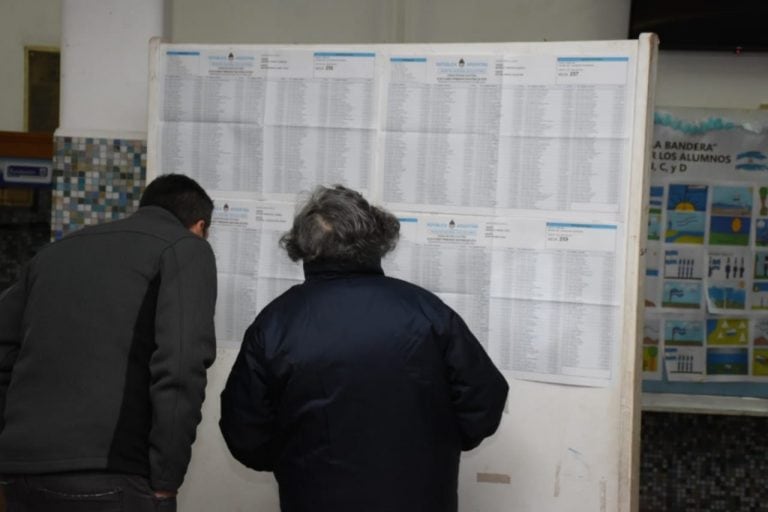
[149,237,216,491]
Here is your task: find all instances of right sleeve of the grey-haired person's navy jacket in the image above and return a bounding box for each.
[444,312,509,450]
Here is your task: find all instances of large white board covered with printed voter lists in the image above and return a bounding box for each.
[148,35,657,512]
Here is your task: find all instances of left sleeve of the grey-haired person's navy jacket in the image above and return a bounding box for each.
[219,320,277,471]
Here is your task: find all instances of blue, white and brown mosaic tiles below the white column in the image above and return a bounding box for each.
[51,137,147,240]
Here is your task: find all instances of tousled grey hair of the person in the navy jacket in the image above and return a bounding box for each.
[280,185,400,263]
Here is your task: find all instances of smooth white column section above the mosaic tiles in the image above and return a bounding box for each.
[56,0,170,139]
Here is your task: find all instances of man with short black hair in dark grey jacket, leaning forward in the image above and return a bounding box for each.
[0,175,216,512]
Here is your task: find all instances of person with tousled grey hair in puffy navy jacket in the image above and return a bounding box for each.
[220,186,508,512]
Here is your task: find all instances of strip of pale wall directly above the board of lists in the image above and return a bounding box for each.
[172,0,629,44]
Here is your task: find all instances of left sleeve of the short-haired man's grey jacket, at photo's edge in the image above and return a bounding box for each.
[0,270,26,432]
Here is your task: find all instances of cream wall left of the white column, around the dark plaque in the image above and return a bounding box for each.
[0,0,61,131]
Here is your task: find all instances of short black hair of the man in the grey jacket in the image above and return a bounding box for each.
[139,174,213,230]
